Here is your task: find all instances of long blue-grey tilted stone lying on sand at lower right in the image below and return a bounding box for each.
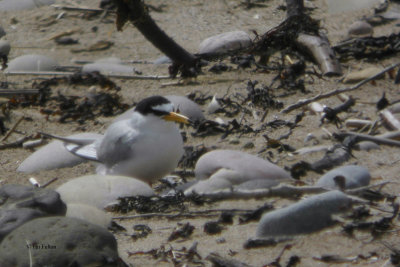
[256,191,352,238]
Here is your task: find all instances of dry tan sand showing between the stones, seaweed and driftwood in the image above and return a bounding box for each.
[0,0,400,266]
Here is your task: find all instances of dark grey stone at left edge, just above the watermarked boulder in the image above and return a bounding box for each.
[0,184,66,242]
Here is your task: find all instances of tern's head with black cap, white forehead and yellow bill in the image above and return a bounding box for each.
[135,96,190,124]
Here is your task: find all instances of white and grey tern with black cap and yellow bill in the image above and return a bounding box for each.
[45,96,189,183]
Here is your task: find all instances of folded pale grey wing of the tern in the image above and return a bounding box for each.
[97,123,140,167]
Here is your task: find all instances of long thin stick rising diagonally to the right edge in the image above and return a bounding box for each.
[281,62,400,113]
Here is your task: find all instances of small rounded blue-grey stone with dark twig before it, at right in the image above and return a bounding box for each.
[315,165,371,189]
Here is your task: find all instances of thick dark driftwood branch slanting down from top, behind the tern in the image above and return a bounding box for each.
[114,0,197,76]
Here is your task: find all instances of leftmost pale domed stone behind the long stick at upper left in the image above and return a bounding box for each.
[6,55,59,72]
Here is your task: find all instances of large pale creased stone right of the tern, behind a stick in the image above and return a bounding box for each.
[185,150,292,194]
